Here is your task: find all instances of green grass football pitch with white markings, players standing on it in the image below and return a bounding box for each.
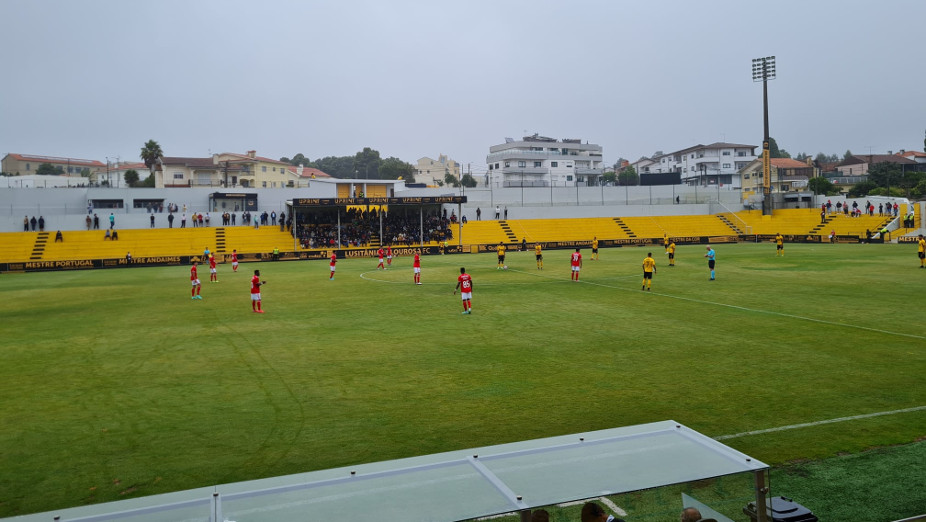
[0,243,926,516]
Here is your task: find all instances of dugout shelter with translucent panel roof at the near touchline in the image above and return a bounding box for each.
[7,420,768,522]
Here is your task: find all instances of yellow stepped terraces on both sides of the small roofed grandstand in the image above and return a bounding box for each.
[0,205,923,262]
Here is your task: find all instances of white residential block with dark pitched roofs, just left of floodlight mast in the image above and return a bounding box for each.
[632,142,758,189]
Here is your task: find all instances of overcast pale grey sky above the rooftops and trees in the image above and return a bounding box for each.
[0,0,926,172]
